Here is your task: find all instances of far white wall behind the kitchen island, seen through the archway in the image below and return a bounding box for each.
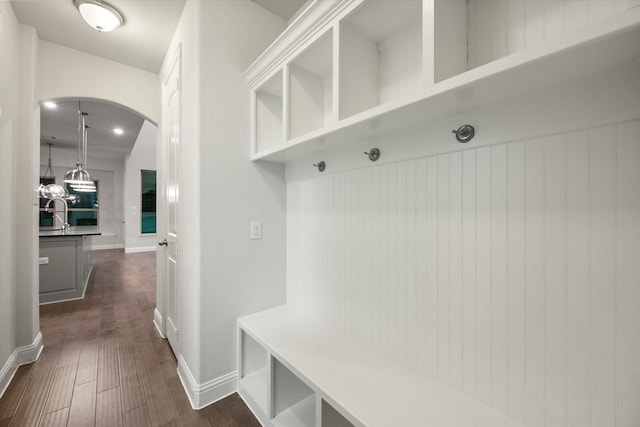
[40,146,124,250]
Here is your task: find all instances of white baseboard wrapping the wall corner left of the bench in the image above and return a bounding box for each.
[178,355,238,410]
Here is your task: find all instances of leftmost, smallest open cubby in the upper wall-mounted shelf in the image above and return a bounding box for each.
[254,70,284,152]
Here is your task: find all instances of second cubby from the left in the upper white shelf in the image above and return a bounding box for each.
[288,31,333,139]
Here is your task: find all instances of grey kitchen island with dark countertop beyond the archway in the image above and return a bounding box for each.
[40,226,101,304]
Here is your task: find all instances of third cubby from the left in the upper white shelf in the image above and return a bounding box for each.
[339,0,424,119]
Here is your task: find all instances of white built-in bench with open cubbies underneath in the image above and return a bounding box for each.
[238,306,522,427]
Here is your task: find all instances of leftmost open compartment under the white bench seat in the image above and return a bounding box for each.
[238,329,269,417]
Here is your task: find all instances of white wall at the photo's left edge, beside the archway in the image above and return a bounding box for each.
[0,1,42,393]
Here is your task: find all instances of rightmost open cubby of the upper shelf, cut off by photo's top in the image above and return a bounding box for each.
[432,0,634,83]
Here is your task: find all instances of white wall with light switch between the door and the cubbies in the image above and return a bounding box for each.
[199,1,286,392]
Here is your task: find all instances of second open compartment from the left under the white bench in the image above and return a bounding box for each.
[271,358,316,427]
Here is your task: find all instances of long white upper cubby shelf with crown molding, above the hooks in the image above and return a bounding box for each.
[245,0,640,163]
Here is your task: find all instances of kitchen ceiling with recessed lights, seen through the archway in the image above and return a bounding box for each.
[40,99,144,157]
